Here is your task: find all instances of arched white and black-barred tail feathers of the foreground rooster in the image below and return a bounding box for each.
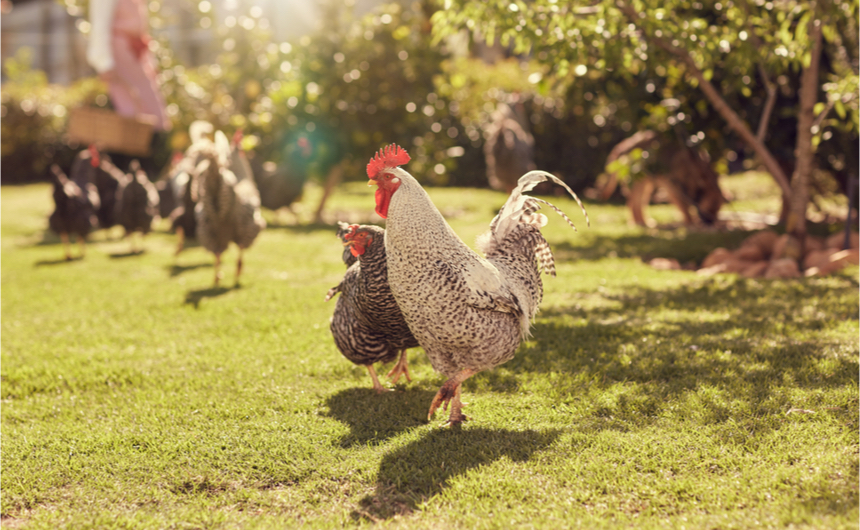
[479,170,591,276]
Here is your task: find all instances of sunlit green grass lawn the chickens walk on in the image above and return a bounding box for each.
[0,175,860,529]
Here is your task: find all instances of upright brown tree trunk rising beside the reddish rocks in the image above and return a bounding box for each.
[785,17,822,259]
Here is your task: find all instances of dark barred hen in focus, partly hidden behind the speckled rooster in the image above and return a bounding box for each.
[326,225,418,392]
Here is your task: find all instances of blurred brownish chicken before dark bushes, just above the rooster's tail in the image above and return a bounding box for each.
[484,103,535,193]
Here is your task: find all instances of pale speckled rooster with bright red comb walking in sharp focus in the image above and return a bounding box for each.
[367,145,588,426]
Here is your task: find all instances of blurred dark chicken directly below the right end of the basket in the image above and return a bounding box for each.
[116,160,158,252]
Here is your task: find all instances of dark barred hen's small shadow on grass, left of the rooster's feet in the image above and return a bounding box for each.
[326,384,436,447]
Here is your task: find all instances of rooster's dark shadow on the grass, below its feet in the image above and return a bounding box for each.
[352,425,560,521]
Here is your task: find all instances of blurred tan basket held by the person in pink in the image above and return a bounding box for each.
[69,107,152,156]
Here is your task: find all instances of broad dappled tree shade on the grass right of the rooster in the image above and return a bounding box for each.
[474,277,858,438]
